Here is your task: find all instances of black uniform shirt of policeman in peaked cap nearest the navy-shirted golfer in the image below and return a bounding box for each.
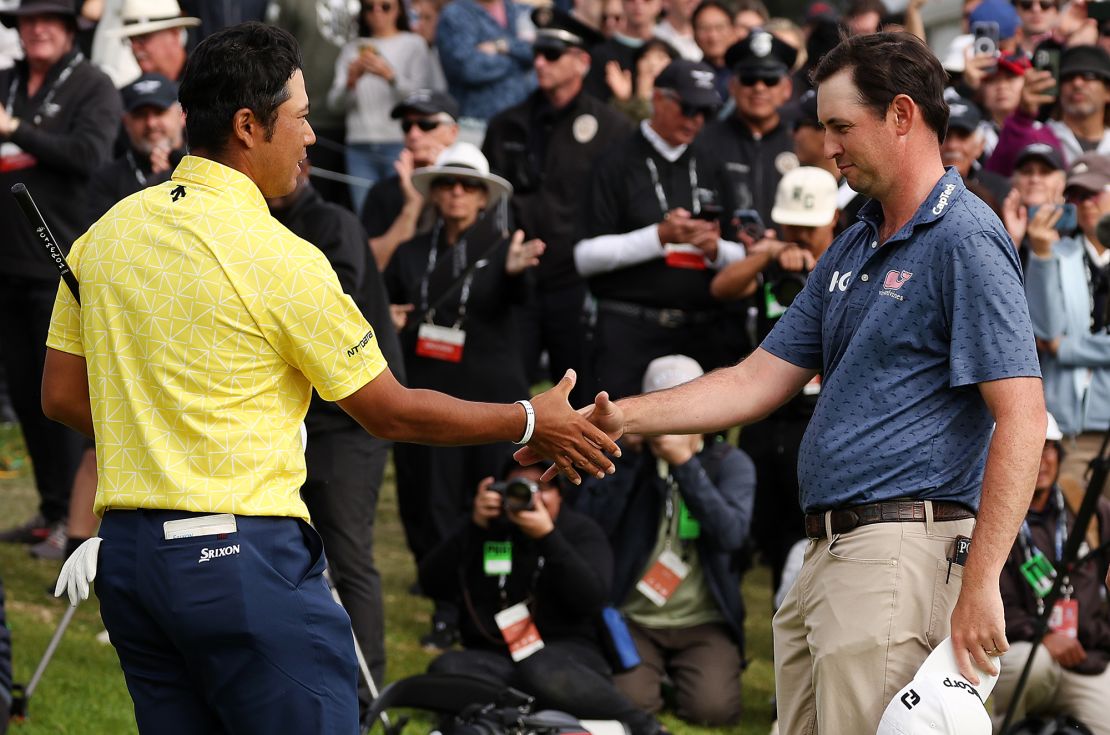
[694,114,798,230]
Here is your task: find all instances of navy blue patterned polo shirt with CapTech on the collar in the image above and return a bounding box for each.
[761,169,1040,513]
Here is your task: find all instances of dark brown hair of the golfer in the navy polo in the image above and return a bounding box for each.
[814,31,948,140]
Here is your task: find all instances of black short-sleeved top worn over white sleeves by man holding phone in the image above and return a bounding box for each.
[581,130,731,311]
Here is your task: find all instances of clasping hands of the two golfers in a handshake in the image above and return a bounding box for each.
[514,381,624,484]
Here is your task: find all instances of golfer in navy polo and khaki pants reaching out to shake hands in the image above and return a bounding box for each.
[518,33,1046,735]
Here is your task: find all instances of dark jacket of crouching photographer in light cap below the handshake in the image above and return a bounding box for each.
[576,442,756,653]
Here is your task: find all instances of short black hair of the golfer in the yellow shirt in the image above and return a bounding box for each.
[178,22,301,153]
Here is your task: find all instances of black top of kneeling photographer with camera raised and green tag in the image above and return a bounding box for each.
[420,510,613,651]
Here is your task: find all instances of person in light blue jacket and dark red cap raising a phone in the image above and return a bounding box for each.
[1026,153,1110,477]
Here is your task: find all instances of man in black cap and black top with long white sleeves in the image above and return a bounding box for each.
[574,59,744,397]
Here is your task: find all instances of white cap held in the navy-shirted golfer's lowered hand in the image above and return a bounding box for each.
[876,638,1001,735]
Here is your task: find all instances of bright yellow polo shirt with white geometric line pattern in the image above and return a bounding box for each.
[47,155,385,518]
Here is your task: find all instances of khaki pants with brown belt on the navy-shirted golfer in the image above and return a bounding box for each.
[773,512,975,735]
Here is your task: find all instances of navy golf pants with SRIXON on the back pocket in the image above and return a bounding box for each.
[95,511,359,735]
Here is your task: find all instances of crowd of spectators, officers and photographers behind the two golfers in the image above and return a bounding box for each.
[0,0,1110,735]
